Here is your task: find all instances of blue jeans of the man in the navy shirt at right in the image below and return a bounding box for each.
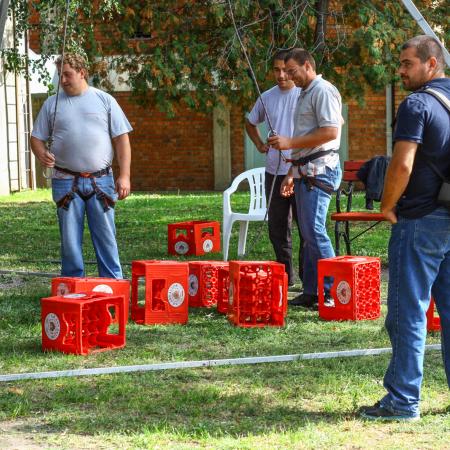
[381,208,450,416]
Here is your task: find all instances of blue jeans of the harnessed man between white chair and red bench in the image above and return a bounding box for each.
[294,165,342,295]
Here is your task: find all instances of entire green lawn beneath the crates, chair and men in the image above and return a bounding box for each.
[0,190,450,449]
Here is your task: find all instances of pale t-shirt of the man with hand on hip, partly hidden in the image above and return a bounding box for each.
[248,86,301,175]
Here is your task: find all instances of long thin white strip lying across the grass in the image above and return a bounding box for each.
[0,344,441,383]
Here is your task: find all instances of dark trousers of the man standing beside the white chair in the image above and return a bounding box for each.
[265,172,303,284]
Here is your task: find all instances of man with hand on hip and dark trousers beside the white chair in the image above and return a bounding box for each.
[245,51,302,285]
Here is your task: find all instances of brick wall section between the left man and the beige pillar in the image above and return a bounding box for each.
[115,92,214,191]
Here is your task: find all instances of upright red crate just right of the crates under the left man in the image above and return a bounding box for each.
[131,260,189,325]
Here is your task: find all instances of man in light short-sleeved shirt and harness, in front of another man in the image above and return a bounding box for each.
[269,48,342,308]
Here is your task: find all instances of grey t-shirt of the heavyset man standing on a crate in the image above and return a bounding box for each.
[31,86,132,172]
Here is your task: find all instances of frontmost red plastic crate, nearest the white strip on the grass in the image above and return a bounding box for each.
[41,293,126,355]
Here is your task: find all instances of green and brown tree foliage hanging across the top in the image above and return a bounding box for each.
[3,0,450,112]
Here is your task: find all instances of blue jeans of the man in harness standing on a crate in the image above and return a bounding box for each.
[52,174,122,278]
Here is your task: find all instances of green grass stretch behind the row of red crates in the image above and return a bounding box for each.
[0,189,389,276]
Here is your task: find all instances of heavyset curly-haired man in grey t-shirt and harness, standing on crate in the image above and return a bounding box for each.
[31,54,132,278]
